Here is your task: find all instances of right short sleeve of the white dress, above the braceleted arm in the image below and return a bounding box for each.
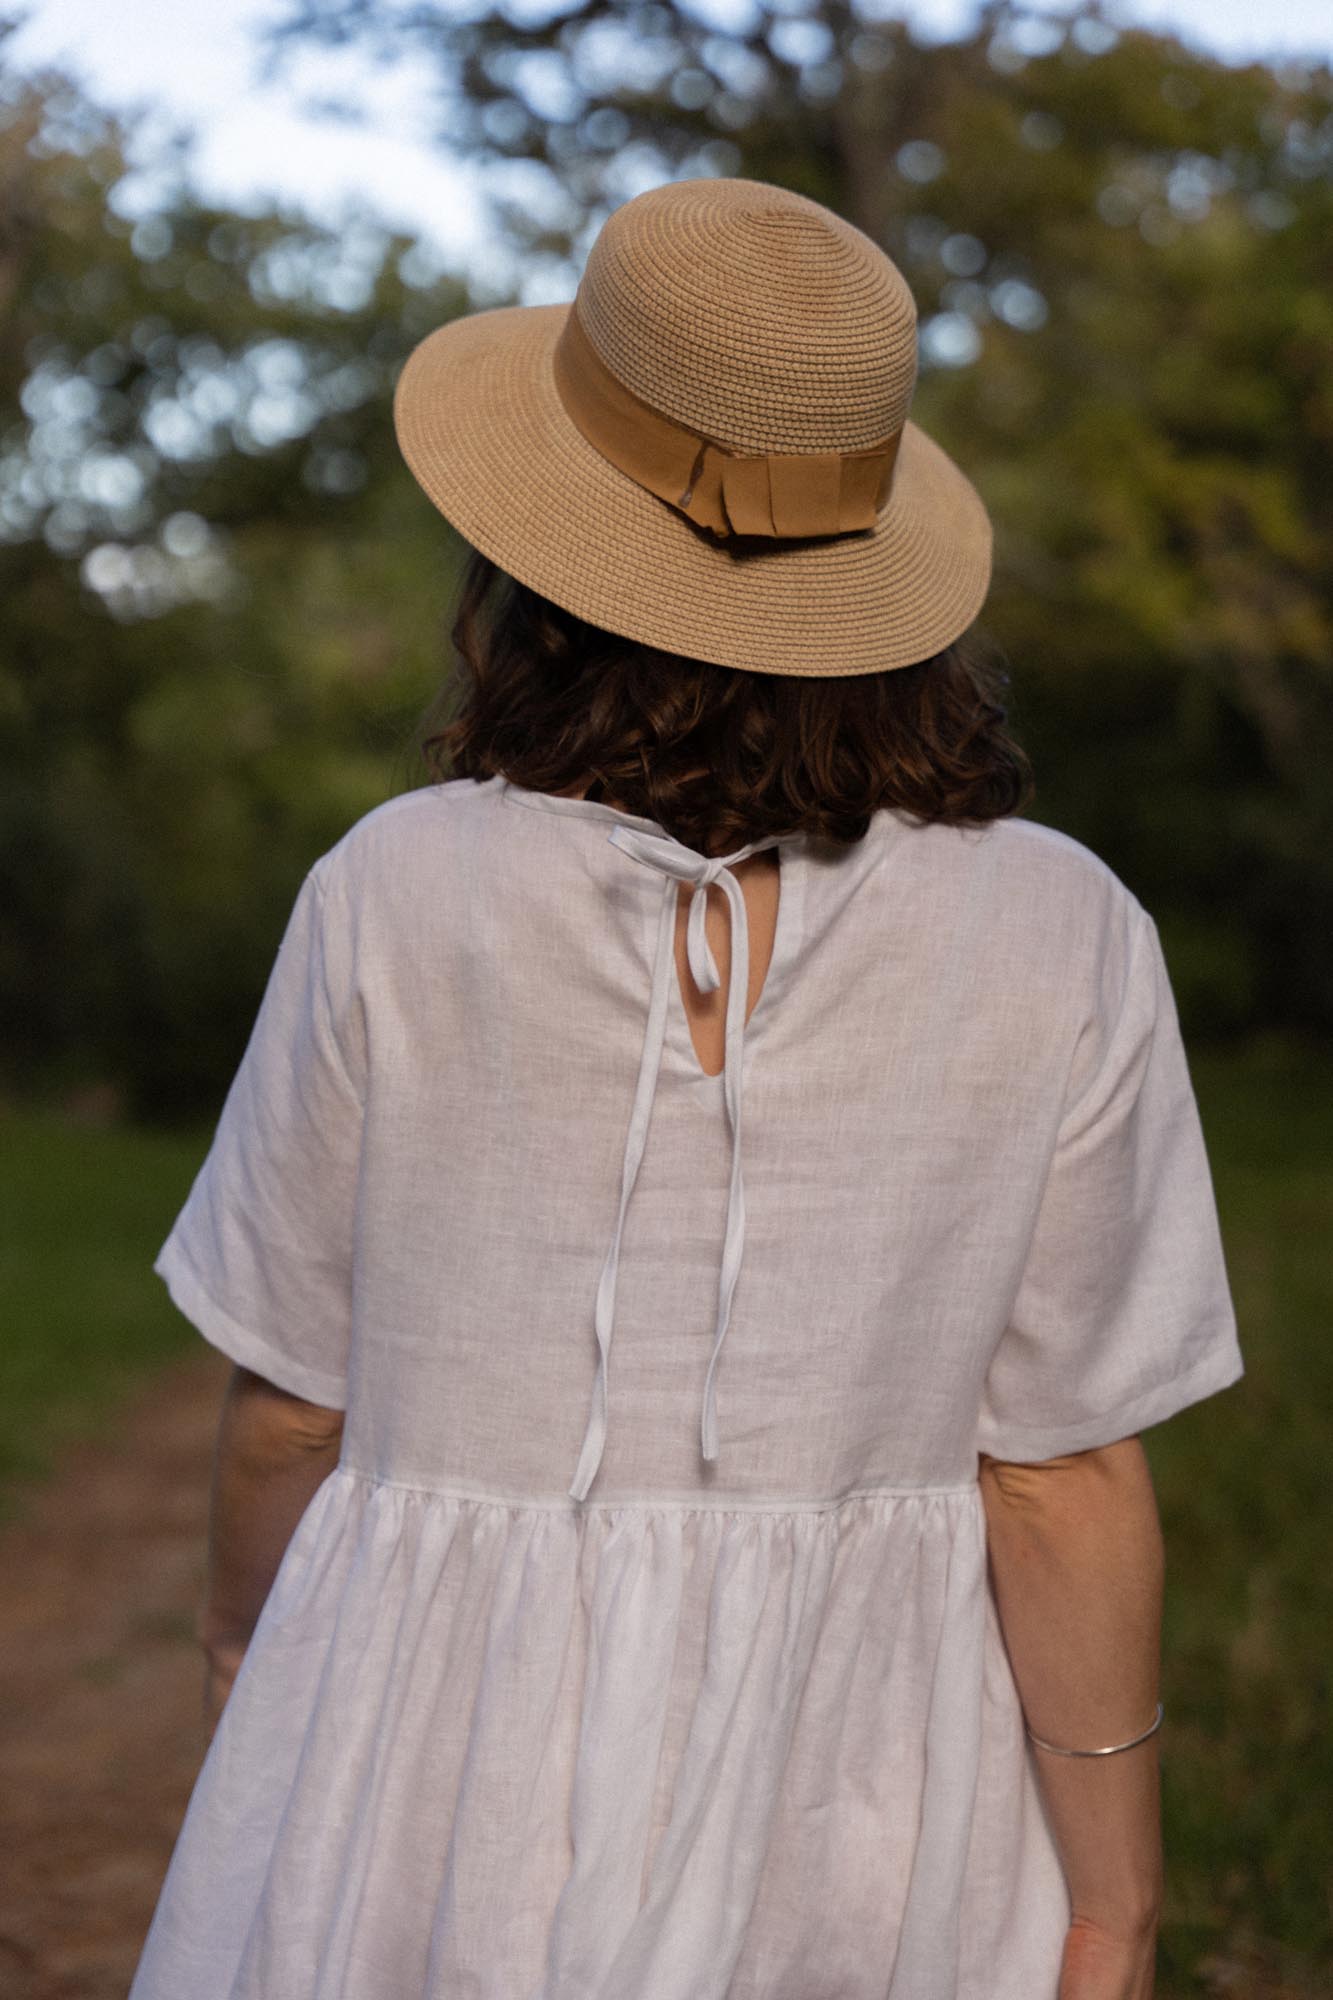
[977,898,1245,1462]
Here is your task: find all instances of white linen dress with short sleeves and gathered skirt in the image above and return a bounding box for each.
[130,778,1243,2000]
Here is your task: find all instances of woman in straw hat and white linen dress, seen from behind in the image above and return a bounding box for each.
[132,180,1241,2000]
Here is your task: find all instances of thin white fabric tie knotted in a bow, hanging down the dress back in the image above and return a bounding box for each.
[568,826,789,1500]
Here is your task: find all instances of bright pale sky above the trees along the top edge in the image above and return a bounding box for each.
[8,0,1333,292]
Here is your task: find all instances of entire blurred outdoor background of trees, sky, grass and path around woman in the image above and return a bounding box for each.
[0,0,1333,2000]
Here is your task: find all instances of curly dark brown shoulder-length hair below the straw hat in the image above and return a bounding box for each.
[420,550,1033,856]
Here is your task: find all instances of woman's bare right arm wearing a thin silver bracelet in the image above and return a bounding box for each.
[981,1438,1165,1934]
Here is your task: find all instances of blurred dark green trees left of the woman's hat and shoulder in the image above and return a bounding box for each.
[0,31,466,1116]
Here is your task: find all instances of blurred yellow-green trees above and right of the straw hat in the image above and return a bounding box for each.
[266,0,1333,1030]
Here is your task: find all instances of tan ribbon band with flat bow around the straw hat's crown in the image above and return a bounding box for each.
[552,306,903,538]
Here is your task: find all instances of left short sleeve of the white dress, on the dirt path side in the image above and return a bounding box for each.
[152,862,364,1410]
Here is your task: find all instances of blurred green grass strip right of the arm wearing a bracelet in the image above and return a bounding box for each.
[1145,1040,1333,2000]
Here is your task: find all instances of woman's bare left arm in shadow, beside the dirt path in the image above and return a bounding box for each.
[196,1366,342,1736]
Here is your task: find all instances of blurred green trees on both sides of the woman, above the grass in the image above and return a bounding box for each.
[0,0,1333,1116]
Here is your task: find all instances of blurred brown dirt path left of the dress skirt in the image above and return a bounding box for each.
[0,1350,228,2000]
